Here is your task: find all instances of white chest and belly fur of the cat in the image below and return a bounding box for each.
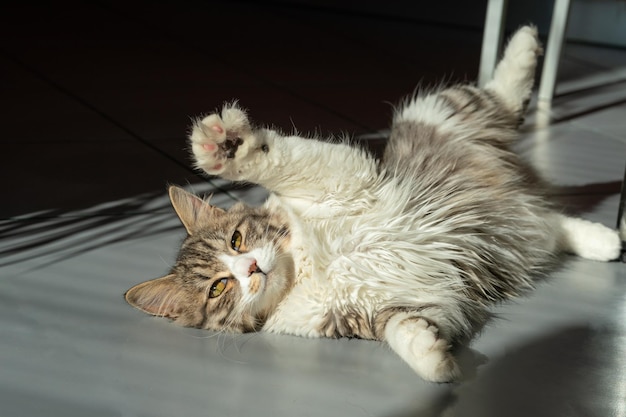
[263,192,461,338]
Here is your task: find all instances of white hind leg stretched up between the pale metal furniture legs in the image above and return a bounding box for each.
[485,26,542,116]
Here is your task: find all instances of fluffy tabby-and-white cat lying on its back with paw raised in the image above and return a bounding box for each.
[126,26,621,382]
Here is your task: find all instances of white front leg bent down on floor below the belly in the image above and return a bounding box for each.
[384,312,461,382]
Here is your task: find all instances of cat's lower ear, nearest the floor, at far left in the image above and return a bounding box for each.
[124,275,187,319]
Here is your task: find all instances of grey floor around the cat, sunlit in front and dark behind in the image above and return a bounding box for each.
[0,0,626,417]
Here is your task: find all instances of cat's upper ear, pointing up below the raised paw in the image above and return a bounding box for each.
[169,186,226,235]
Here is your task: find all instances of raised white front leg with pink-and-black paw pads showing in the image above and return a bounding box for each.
[190,105,378,202]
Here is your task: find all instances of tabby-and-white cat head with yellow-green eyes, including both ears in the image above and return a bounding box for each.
[125,187,294,332]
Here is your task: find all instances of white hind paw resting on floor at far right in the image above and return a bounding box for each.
[557,214,622,262]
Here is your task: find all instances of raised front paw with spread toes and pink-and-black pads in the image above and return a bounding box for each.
[190,106,253,175]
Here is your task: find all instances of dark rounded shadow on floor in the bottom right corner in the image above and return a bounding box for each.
[378,326,626,417]
